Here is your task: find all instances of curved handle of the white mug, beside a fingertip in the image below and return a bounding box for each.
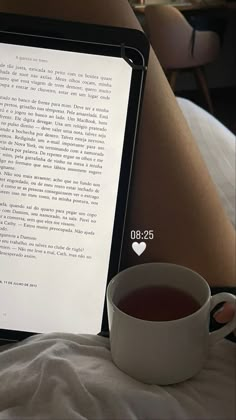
[210,292,236,345]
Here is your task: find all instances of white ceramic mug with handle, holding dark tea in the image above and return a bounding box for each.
[107,263,236,385]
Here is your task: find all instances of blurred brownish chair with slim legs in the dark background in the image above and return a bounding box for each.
[145,4,220,114]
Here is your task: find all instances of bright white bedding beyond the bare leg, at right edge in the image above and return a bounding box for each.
[177,98,236,226]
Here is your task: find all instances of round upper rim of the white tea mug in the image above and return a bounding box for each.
[106,262,211,325]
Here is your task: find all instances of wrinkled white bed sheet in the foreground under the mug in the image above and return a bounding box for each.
[0,334,236,420]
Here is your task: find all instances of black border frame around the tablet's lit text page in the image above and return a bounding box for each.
[0,13,149,341]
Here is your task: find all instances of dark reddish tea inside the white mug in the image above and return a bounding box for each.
[117,286,201,321]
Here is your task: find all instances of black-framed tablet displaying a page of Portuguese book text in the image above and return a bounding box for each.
[0,14,149,340]
